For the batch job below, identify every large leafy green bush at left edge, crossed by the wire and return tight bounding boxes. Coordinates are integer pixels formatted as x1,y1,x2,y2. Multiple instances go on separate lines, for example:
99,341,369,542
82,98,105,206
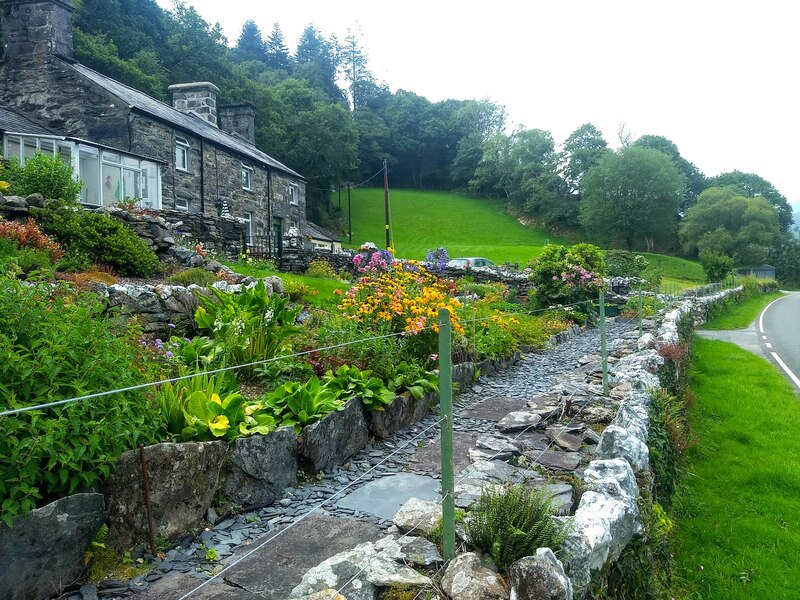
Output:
0,279,161,523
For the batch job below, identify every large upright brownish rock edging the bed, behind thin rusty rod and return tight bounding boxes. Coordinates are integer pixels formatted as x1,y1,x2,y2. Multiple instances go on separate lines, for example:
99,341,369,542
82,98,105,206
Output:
102,442,227,550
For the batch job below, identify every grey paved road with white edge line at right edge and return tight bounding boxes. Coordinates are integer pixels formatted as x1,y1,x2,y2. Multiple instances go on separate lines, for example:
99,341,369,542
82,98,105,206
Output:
757,293,800,389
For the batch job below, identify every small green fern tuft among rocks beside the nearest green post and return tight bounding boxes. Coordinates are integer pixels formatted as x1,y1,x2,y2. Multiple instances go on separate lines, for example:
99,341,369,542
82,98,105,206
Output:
465,483,570,571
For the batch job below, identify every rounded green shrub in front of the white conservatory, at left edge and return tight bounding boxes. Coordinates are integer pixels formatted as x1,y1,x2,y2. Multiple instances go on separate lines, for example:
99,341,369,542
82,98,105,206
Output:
3,152,83,204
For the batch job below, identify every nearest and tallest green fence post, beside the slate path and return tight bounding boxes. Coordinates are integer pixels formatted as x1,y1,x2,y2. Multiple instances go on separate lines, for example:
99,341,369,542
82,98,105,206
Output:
439,308,456,562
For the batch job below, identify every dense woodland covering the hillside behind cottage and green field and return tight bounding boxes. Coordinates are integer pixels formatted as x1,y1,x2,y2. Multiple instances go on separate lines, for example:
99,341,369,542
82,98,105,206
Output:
10,0,800,279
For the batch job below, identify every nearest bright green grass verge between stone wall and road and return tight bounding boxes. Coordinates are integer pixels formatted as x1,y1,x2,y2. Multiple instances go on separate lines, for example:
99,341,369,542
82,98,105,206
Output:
674,339,800,600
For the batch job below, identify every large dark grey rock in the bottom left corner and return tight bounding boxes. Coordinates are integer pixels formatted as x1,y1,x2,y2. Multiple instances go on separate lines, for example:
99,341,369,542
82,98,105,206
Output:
0,494,106,600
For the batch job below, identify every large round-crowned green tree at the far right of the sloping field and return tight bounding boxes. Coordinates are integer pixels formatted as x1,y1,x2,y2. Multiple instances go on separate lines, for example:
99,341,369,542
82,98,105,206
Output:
579,147,684,250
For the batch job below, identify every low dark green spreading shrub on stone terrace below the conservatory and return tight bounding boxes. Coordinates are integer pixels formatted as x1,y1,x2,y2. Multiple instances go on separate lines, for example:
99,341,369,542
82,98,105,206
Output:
31,208,161,277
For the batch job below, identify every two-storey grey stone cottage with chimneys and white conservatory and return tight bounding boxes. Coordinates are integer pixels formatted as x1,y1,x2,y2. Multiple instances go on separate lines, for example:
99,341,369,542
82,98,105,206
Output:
0,0,308,253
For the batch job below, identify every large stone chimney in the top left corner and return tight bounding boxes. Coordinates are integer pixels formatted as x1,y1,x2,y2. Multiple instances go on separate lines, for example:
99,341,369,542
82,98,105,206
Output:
0,0,75,63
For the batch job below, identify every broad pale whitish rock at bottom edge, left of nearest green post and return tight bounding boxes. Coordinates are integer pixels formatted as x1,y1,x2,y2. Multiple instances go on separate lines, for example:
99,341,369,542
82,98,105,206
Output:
289,542,430,600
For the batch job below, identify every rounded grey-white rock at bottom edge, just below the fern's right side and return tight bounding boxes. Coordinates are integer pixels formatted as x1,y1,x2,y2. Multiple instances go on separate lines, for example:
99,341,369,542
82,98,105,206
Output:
508,548,572,600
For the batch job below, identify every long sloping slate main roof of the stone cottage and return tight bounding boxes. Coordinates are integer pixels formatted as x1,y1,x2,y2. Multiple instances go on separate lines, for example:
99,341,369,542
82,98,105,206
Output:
64,61,305,181
